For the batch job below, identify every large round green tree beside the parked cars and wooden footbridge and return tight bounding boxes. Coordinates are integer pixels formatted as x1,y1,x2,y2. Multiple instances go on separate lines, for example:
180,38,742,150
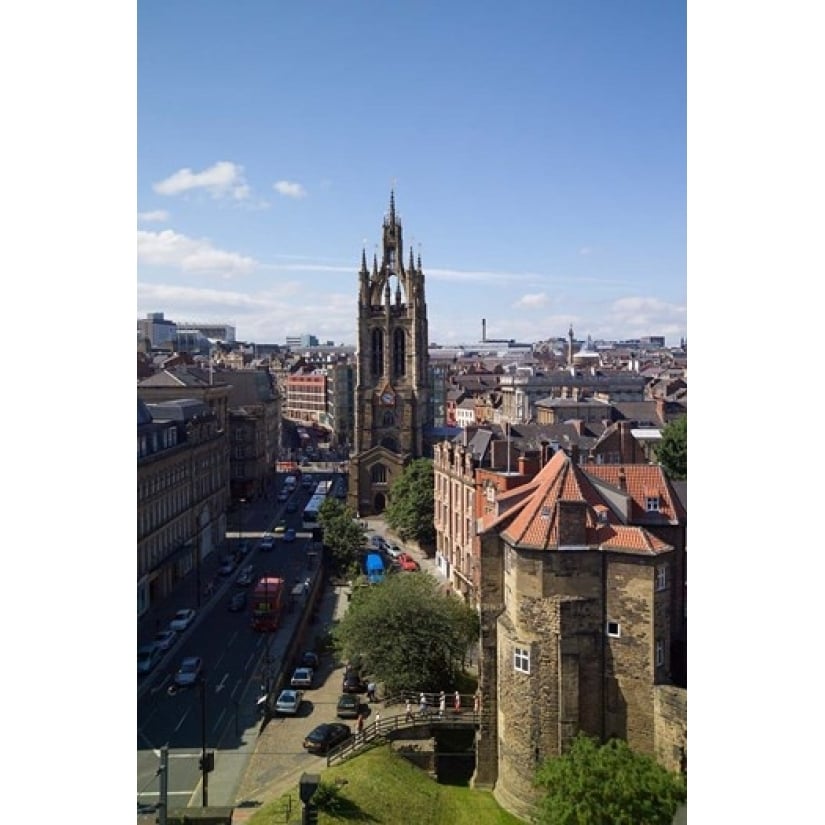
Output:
333,572,479,693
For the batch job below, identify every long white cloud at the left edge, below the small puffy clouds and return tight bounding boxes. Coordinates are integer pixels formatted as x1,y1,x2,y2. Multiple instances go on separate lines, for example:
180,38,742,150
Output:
137,229,258,278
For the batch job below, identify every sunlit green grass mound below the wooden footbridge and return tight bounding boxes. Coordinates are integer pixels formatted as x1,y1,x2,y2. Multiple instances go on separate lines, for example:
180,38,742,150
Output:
241,745,523,825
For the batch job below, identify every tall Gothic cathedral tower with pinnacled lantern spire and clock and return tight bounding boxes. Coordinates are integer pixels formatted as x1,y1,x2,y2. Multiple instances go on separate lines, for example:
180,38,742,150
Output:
348,192,429,517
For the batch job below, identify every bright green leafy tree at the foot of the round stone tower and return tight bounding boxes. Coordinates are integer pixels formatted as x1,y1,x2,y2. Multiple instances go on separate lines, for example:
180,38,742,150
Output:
534,734,687,825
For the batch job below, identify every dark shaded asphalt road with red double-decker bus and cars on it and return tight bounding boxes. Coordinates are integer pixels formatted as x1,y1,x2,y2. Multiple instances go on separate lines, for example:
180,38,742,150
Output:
137,474,330,823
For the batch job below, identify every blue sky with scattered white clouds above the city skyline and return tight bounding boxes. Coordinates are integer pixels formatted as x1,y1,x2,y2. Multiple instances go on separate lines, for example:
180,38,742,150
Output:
137,0,687,345
